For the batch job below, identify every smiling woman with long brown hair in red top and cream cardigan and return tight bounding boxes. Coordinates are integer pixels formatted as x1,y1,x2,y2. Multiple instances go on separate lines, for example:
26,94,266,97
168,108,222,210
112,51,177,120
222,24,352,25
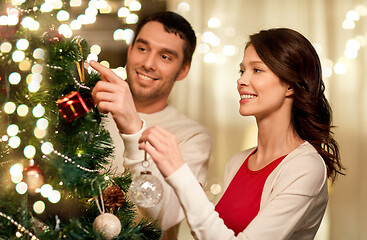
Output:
140,28,343,240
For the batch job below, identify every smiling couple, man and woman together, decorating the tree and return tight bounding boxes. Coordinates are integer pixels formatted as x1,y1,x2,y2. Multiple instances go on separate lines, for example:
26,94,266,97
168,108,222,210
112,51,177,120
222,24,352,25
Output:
90,12,343,240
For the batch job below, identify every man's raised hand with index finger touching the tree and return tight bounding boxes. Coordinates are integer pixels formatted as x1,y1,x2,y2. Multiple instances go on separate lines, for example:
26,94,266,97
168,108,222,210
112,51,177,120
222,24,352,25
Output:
89,61,142,134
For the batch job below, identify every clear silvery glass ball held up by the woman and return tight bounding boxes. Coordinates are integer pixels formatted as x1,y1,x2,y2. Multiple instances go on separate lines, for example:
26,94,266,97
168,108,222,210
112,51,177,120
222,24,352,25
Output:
129,171,163,208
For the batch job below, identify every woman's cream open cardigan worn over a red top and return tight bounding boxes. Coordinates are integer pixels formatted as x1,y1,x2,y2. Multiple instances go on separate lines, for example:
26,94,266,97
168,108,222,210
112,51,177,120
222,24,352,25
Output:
166,142,328,240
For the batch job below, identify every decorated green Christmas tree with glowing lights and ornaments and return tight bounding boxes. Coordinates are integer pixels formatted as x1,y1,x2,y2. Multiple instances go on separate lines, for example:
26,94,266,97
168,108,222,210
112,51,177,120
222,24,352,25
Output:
0,0,161,240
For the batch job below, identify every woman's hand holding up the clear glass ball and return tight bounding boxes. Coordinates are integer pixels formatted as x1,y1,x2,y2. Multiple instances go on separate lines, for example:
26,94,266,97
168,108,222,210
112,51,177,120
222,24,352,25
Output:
139,126,185,177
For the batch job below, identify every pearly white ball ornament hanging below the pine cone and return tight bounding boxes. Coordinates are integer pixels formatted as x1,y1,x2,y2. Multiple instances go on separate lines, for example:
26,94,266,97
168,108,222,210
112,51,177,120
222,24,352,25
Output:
93,213,121,240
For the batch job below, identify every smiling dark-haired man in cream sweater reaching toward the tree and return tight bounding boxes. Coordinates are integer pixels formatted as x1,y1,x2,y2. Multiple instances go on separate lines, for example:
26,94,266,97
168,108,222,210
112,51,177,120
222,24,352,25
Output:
90,12,211,240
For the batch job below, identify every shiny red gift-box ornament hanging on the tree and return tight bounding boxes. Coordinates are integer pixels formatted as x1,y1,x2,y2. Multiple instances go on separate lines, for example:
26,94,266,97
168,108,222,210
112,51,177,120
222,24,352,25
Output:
57,91,93,122
